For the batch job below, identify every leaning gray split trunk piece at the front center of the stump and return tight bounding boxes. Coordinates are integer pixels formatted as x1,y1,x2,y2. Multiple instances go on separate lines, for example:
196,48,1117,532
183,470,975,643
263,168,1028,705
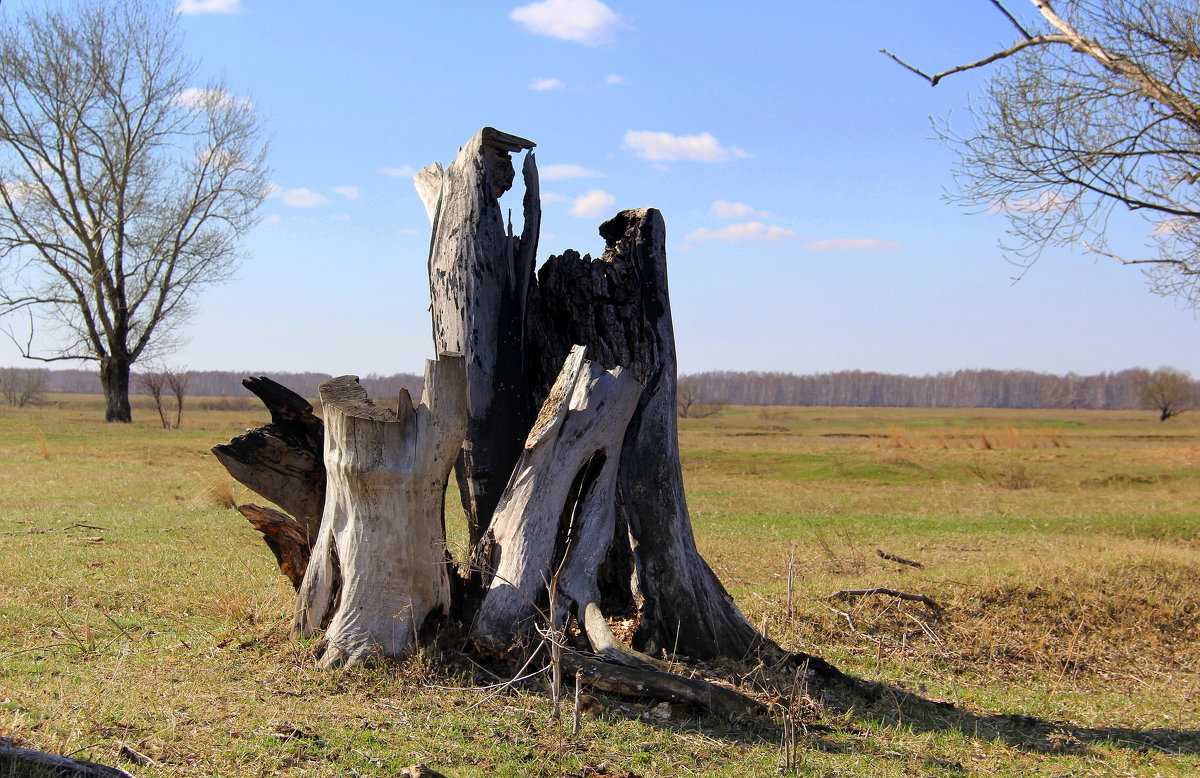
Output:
472,347,641,652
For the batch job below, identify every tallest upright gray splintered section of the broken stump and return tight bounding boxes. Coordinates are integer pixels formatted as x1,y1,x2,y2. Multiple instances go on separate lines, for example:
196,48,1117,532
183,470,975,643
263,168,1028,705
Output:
415,127,541,545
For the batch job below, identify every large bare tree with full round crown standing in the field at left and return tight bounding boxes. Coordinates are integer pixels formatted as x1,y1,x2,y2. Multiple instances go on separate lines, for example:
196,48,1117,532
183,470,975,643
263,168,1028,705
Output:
0,0,266,421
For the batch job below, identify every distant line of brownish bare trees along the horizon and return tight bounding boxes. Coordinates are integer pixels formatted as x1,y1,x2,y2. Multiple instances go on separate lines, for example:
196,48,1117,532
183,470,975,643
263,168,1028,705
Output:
14,367,1200,409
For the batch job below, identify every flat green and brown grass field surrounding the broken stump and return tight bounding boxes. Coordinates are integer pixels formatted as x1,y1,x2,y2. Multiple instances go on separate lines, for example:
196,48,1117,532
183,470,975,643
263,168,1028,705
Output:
0,397,1200,778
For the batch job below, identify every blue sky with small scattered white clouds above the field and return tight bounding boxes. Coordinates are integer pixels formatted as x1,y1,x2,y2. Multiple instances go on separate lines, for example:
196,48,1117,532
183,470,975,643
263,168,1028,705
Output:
0,0,1200,375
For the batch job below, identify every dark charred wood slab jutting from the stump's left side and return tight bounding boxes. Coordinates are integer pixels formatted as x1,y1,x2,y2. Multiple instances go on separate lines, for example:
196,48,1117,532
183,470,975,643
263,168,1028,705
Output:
212,376,325,538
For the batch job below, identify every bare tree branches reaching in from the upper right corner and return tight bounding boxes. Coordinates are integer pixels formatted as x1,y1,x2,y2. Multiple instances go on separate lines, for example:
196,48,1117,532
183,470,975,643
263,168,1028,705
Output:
884,0,1200,306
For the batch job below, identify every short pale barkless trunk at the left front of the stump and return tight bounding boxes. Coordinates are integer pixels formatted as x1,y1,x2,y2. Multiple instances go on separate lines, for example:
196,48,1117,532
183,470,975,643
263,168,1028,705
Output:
293,357,466,666
